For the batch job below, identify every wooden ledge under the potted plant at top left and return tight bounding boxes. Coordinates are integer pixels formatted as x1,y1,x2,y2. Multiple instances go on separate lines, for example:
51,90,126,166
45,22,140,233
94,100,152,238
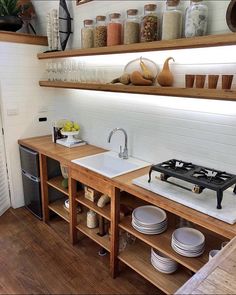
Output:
0,31,48,46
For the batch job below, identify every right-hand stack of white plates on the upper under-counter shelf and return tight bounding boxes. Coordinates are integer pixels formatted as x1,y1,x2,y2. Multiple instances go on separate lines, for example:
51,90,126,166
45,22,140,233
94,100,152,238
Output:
171,227,205,257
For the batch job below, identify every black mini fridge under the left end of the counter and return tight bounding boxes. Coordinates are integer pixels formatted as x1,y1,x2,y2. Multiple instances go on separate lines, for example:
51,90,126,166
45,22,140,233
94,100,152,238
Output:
19,145,42,219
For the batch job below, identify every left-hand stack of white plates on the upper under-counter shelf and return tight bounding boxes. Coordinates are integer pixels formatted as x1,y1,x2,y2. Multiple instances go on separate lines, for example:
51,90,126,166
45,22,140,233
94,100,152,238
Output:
132,205,167,235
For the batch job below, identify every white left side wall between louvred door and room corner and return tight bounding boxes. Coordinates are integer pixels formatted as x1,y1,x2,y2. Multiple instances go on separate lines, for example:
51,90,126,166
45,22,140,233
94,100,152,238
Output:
0,42,55,208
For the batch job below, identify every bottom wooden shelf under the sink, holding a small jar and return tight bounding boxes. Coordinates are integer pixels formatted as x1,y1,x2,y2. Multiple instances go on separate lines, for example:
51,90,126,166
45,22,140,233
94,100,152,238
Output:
76,213,110,252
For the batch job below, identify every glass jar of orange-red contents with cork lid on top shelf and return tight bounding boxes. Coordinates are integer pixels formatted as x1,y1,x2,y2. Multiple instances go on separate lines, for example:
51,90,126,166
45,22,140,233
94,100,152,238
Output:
107,13,122,46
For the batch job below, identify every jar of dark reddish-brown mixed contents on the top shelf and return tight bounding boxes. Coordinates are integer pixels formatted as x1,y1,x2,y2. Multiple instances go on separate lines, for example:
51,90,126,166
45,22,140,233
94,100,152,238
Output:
140,4,160,42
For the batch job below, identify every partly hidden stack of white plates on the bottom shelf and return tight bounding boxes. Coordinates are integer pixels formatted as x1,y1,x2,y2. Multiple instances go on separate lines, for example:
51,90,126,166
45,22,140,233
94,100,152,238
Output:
151,248,178,274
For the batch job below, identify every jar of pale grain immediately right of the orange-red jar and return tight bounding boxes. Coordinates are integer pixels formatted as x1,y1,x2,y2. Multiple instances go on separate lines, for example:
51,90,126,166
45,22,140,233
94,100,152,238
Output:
124,9,140,44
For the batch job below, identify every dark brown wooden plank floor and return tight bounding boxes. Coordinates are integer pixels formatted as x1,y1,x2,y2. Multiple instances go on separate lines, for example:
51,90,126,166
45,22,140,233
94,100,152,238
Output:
0,208,162,294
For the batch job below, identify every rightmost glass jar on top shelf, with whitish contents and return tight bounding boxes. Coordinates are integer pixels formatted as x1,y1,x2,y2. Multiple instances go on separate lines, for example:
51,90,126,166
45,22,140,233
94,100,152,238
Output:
185,0,208,38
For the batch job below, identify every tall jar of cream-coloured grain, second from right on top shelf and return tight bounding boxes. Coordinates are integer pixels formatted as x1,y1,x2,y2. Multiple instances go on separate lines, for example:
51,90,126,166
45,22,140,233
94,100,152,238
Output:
162,0,183,40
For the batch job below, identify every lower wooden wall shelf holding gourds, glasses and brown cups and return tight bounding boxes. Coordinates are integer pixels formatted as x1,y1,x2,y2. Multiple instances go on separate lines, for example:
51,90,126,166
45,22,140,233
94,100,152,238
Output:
39,81,236,101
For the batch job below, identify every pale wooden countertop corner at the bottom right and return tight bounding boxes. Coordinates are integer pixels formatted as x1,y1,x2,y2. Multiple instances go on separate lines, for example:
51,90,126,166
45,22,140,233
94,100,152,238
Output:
175,238,236,295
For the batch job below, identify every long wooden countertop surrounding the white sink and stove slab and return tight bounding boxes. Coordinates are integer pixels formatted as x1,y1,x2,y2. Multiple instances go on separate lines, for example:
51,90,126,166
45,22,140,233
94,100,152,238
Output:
18,135,236,239
